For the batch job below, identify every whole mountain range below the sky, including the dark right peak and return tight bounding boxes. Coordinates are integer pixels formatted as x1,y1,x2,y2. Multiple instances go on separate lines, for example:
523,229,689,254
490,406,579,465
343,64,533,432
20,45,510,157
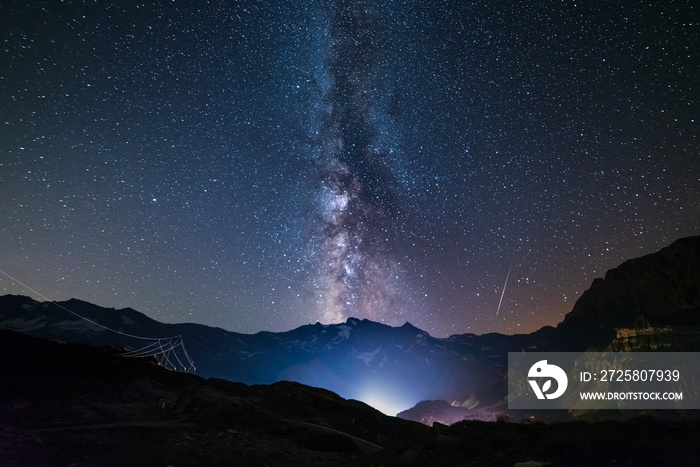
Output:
0,236,700,424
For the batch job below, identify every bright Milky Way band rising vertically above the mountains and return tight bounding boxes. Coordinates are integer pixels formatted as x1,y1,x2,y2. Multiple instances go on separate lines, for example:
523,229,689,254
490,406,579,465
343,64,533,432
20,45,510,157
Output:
310,2,410,322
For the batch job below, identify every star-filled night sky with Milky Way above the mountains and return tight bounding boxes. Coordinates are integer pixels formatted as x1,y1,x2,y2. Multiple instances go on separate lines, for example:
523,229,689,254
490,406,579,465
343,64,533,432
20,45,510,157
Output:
0,0,700,337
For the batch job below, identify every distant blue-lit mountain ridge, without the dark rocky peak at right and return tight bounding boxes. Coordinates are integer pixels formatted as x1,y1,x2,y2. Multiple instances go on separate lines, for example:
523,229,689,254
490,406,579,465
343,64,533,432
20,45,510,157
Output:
0,296,536,414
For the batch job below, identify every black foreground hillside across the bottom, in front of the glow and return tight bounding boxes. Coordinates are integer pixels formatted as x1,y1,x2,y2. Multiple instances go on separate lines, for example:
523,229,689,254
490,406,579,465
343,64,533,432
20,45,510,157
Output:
0,331,700,467
